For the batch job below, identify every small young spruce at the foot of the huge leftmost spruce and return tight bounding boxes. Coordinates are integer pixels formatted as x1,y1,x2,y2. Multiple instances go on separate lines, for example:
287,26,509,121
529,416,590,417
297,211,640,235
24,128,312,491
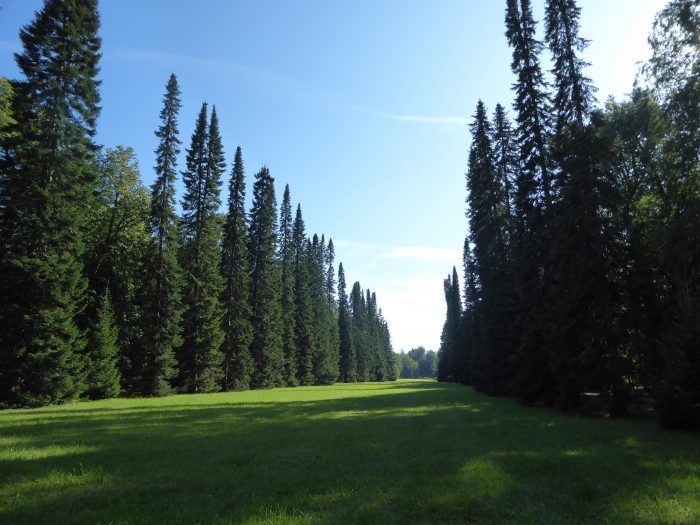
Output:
85,290,121,399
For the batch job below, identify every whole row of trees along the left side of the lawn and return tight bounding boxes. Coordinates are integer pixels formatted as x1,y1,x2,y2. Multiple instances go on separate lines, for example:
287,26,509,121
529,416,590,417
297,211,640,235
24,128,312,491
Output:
0,0,396,406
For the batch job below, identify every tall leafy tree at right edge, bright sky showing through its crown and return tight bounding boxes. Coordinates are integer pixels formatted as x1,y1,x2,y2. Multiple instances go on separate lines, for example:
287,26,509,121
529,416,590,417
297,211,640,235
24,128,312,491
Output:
646,0,700,430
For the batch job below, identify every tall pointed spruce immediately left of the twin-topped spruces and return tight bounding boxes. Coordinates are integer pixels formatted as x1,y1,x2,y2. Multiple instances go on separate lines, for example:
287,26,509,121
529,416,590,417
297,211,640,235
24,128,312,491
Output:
138,74,182,395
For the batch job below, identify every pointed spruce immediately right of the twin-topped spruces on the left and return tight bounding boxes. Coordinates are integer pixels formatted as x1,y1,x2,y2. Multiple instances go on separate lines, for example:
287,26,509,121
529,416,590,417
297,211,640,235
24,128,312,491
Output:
221,146,253,390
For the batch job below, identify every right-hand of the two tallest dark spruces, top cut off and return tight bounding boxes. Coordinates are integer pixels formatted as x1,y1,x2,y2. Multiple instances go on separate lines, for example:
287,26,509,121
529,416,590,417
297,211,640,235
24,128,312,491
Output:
546,0,625,410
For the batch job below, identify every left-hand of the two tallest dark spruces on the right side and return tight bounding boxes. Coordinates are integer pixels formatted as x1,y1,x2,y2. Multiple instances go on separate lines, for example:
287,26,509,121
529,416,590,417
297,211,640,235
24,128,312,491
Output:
506,0,554,402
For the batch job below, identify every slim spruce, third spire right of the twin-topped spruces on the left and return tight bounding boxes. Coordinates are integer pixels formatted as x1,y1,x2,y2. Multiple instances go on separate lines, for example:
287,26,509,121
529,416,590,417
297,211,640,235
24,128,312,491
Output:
279,184,298,386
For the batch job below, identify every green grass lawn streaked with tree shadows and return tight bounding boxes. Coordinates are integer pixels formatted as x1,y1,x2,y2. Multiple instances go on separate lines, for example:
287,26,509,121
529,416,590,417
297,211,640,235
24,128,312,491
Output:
0,381,700,525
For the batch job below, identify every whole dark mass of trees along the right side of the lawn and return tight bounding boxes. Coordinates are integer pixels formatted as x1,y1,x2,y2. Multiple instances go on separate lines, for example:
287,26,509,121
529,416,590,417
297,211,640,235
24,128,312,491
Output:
438,0,700,430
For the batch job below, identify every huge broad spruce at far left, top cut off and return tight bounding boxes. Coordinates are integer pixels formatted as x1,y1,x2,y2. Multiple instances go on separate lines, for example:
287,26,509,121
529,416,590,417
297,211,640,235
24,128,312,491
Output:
0,0,100,405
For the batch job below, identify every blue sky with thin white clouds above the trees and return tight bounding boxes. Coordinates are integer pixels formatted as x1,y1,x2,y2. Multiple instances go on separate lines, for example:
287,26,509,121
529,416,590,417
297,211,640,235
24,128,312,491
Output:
0,0,665,351
